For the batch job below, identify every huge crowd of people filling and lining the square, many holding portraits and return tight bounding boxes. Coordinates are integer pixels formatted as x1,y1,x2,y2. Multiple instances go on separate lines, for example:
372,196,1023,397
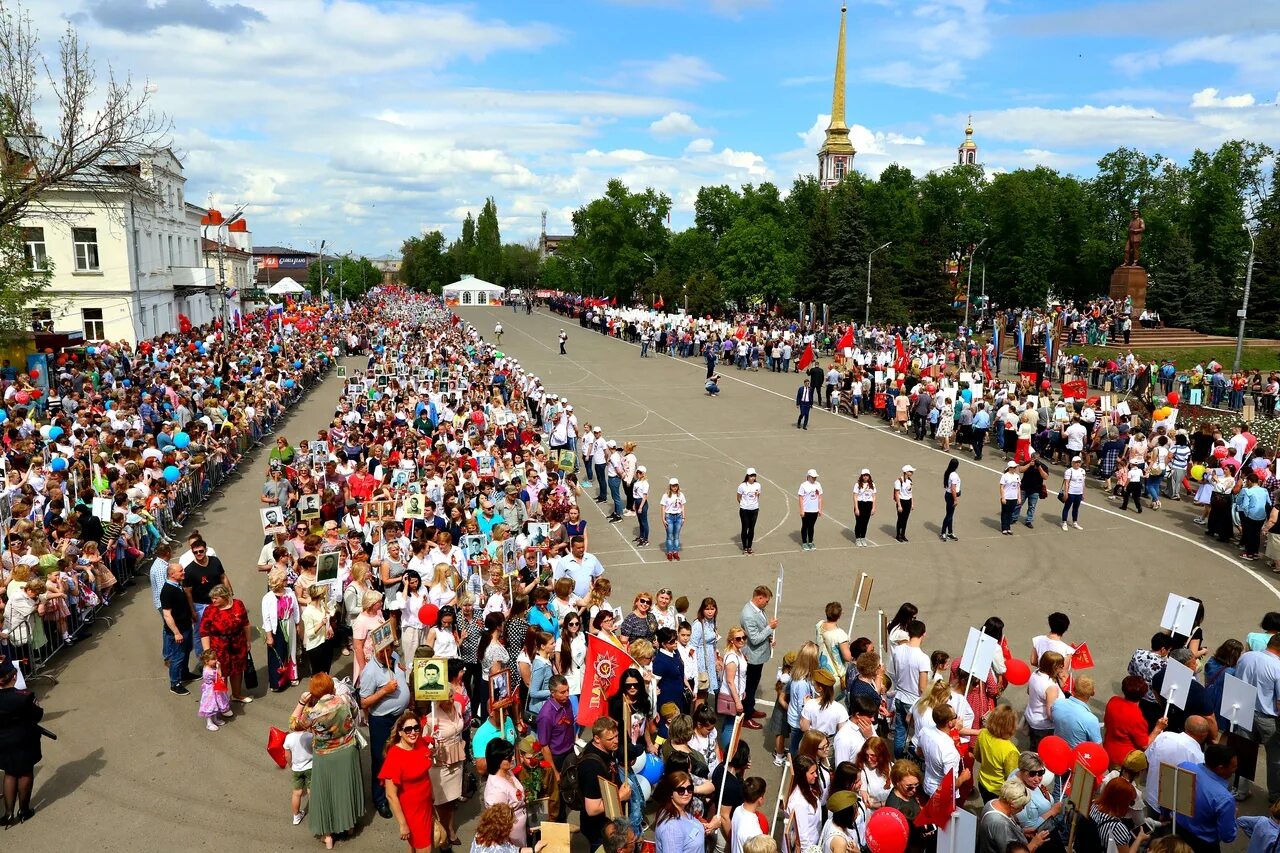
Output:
0,288,1280,853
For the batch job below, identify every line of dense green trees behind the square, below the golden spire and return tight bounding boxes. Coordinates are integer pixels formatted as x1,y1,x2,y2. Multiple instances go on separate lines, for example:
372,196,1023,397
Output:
394,141,1280,337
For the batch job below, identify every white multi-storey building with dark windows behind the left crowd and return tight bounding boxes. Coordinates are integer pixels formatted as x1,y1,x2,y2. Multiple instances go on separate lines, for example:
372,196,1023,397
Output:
22,150,220,343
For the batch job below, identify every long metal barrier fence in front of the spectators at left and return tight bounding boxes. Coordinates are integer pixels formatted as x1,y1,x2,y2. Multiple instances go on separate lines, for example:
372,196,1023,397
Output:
0,362,333,683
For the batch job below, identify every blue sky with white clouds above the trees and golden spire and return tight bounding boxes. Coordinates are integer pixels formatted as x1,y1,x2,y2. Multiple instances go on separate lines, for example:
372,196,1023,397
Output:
27,0,1280,255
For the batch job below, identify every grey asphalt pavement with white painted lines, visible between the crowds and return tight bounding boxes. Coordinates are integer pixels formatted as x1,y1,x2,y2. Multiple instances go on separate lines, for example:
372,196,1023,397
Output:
17,309,1280,853
